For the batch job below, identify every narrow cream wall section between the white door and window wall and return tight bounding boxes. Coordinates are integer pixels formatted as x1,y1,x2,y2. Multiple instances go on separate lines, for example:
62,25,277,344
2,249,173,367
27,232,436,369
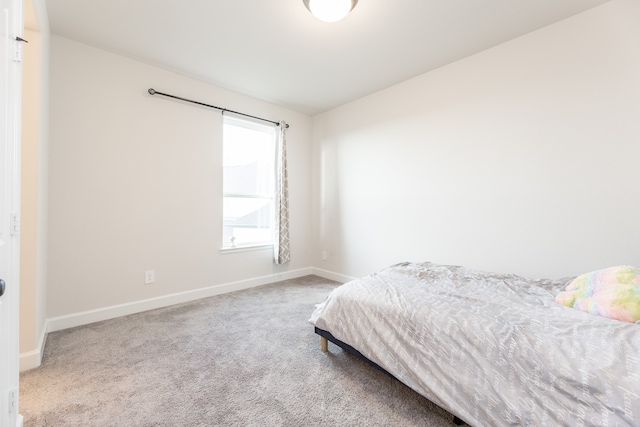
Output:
20,0,49,370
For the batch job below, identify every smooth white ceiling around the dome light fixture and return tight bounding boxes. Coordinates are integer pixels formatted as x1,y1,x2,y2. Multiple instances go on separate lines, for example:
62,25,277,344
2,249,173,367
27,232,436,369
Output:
41,0,608,115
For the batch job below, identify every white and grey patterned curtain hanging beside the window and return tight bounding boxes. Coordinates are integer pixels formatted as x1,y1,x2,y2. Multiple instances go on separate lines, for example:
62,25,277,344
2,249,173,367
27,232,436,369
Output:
273,121,291,264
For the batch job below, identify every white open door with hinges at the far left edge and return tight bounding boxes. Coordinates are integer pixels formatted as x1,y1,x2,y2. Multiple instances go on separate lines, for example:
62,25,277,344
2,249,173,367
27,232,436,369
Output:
0,0,23,427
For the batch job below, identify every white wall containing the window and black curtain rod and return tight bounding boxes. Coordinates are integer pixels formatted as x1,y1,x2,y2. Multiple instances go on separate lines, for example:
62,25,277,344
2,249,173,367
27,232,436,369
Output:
48,36,311,318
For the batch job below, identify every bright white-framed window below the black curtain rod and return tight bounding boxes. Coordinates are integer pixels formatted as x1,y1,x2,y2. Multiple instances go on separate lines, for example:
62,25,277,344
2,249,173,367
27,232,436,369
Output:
222,115,276,249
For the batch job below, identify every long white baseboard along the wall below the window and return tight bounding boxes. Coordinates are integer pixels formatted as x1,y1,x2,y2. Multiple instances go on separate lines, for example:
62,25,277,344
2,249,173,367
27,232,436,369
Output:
48,268,314,332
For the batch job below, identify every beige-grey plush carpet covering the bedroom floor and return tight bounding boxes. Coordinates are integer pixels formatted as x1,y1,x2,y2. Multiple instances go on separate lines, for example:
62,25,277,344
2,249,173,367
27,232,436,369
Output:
20,276,460,427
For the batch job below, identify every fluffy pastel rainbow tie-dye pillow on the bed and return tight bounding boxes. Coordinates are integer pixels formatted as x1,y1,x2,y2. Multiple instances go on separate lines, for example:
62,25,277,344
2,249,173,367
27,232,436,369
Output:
556,266,640,323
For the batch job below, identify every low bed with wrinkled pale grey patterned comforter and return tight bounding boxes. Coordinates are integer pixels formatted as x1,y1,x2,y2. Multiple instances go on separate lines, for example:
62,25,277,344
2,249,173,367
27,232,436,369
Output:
309,262,640,426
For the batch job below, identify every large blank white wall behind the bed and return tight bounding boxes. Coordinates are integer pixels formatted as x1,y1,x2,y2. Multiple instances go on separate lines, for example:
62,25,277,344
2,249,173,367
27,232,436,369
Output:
313,0,640,278
